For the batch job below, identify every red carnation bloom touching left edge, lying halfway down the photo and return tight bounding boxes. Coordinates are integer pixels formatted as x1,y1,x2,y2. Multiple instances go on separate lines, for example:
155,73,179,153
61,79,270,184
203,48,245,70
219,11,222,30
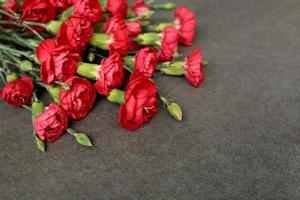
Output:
0,76,33,106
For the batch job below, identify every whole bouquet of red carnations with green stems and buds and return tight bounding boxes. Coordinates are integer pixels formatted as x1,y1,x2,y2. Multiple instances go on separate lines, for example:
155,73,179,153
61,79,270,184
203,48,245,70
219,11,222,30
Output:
0,0,207,151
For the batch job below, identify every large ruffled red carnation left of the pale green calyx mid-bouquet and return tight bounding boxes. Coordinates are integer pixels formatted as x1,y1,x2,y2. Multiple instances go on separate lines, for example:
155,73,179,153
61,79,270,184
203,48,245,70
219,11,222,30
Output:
37,39,81,84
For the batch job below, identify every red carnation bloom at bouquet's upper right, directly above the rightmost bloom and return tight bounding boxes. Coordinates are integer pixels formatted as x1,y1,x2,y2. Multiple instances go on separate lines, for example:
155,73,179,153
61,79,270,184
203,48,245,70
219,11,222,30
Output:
174,6,196,46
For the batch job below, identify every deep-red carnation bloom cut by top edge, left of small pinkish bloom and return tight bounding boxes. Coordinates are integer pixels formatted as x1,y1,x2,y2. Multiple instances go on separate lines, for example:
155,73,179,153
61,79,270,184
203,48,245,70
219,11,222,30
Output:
106,0,128,18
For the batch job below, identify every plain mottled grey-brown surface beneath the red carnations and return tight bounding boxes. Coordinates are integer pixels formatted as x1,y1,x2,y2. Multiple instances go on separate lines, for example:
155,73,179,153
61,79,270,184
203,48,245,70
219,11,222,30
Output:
0,0,300,200
